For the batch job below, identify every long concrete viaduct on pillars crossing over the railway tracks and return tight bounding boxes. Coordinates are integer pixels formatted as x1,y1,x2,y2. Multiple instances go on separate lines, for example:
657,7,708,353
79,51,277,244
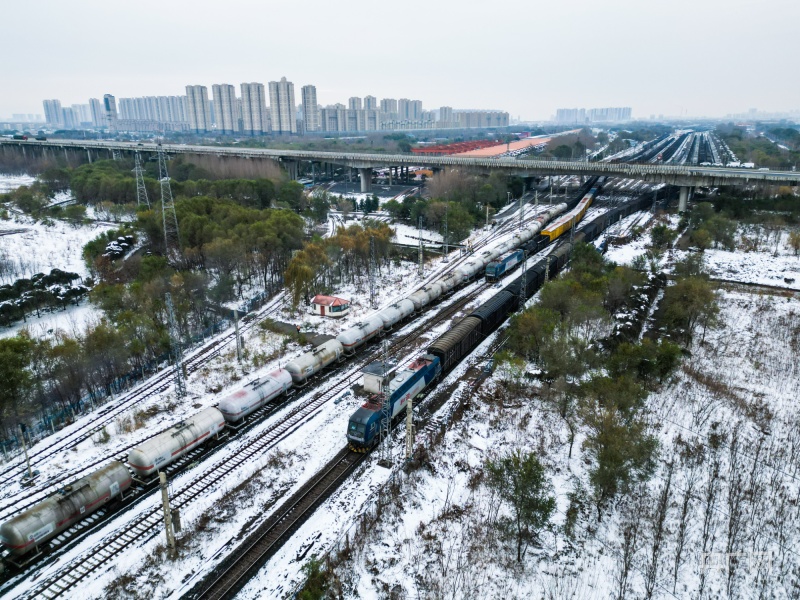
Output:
0,139,800,210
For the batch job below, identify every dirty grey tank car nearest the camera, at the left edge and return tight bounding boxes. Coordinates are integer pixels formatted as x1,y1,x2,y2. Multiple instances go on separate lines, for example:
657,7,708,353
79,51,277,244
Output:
0,460,131,556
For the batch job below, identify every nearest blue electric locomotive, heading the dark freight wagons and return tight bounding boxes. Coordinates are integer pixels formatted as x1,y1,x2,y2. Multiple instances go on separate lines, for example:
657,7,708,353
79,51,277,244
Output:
347,354,442,452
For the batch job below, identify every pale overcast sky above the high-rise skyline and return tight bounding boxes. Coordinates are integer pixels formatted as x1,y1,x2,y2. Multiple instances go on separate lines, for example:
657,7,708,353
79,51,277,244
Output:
0,0,800,119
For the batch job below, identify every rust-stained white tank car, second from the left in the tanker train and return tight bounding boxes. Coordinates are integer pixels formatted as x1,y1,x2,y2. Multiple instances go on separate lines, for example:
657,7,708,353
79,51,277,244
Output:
128,408,225,477
